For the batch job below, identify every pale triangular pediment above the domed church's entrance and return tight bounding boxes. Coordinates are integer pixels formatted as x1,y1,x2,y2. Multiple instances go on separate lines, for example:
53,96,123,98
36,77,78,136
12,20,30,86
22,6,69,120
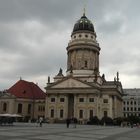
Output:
51,78,91,88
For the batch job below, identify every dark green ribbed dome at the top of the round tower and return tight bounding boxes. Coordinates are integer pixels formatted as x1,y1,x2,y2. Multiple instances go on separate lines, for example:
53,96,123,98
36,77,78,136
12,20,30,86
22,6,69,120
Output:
73,14,94,33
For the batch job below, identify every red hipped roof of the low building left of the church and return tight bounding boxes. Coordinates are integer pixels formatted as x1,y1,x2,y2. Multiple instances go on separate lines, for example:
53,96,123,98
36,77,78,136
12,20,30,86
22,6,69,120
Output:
7,80,46,99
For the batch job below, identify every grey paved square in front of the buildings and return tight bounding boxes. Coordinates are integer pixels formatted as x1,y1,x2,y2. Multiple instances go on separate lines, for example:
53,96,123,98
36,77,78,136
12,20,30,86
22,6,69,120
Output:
0,123,140,140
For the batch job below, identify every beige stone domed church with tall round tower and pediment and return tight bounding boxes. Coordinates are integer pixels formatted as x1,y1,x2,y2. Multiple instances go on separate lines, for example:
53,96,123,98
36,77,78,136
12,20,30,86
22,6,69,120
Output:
45,13,123,123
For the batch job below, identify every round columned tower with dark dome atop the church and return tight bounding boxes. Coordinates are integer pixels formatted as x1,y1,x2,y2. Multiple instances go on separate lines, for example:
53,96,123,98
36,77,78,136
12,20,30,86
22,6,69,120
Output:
67,12,100,82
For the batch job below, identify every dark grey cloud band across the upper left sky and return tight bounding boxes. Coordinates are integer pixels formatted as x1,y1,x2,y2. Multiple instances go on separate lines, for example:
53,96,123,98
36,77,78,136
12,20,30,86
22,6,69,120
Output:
0,0,82,22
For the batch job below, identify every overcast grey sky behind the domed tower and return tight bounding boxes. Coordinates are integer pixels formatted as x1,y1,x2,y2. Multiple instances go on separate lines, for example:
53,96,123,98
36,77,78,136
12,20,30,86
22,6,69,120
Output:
0,0,140,90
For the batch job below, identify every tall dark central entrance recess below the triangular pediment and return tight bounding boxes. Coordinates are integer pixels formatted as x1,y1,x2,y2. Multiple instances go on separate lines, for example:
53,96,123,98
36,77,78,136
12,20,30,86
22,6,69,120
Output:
68,94,74,118
